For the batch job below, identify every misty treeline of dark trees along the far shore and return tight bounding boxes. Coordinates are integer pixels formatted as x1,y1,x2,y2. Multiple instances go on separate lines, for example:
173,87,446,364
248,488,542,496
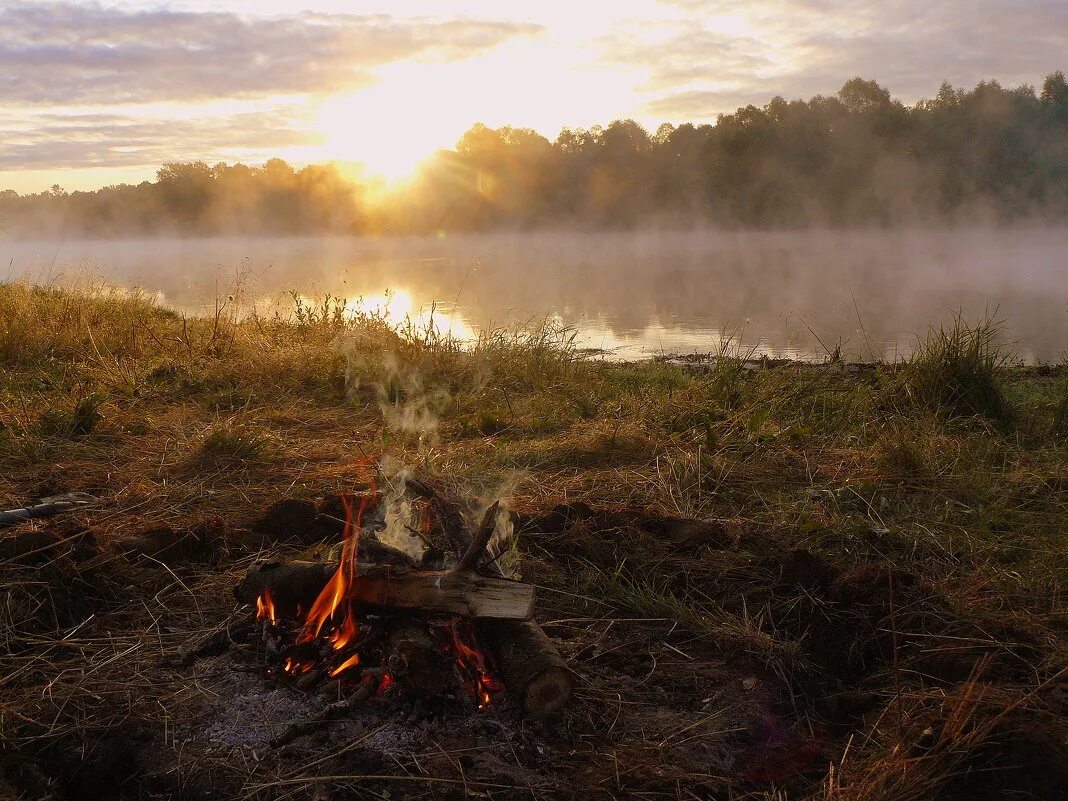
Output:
0,72,1068,237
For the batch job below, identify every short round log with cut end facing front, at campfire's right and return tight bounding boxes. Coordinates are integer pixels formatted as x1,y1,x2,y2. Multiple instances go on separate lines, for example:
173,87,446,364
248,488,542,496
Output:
477,621,575,717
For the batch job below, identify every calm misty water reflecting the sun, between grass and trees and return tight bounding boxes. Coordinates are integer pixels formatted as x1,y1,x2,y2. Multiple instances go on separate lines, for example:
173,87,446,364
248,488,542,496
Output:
0,227,1068,361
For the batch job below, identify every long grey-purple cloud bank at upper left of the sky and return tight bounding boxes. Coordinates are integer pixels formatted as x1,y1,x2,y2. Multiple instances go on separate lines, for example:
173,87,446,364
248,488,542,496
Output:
0,2,541,106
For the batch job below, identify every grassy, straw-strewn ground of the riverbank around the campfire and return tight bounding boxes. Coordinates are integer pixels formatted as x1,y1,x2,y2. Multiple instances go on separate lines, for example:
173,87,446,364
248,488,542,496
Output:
0,285,1068,800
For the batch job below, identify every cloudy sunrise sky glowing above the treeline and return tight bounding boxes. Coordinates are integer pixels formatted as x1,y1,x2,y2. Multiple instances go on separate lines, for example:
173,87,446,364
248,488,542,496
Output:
0,0,1068,192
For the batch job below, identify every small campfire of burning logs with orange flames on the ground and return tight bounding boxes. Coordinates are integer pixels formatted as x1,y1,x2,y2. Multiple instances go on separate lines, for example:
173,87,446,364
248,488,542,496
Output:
235,490,574,735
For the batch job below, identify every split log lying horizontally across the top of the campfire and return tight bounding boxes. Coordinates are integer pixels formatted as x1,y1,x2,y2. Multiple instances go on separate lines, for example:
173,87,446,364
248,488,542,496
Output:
234,562,534,621
